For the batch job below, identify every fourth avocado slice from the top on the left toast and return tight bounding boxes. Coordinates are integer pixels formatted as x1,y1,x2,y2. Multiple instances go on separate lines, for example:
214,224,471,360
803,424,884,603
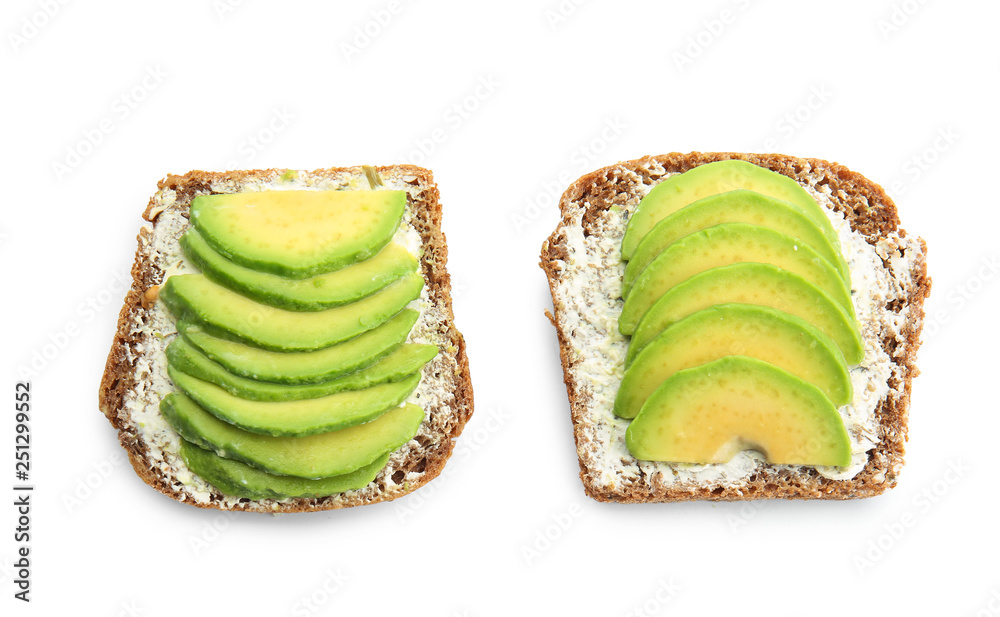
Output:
177,309,420,384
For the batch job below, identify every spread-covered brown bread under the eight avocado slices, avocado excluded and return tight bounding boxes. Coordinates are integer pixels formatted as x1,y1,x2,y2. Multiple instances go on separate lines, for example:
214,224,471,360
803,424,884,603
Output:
99,165,473,513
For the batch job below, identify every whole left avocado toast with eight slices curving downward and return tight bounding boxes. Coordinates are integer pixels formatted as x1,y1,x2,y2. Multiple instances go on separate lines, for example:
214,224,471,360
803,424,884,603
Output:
99,165,473,513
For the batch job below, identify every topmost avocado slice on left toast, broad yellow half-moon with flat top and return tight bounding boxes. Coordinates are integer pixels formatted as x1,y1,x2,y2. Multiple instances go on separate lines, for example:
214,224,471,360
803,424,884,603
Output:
190,191,406,279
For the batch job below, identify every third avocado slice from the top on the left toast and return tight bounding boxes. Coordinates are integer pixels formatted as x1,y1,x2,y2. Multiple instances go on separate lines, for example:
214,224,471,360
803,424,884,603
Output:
159,273,424,351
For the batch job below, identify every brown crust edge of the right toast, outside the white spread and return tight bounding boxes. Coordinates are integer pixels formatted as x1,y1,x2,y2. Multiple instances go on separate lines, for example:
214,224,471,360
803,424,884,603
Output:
540,152,931,503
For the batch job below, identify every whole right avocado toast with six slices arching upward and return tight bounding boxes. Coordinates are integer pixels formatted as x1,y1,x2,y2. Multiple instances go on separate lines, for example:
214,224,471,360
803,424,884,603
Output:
540,152,931,503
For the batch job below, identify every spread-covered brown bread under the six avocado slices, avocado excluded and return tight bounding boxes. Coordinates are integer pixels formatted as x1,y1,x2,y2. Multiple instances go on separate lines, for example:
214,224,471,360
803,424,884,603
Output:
540,152,931,503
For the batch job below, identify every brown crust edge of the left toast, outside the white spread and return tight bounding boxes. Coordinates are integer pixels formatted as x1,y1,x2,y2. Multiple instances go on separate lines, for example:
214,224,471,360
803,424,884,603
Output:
98,165,473,513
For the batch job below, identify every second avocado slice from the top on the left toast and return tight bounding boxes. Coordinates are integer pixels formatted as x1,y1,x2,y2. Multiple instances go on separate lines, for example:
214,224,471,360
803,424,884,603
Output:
181,228,417,311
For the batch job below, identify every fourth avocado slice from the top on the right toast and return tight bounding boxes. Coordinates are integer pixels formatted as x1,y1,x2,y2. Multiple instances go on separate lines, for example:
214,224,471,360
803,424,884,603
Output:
625,263,865,366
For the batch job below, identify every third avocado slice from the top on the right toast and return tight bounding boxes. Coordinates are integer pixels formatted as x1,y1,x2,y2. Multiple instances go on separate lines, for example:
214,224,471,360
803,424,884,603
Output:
618,223,854,335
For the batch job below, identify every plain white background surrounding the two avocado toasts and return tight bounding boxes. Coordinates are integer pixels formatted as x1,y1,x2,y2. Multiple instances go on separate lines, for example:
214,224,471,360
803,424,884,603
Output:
0,0,1000,616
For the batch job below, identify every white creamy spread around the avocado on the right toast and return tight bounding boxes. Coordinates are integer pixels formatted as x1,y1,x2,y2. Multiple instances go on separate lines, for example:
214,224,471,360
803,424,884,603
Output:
553,163,921,488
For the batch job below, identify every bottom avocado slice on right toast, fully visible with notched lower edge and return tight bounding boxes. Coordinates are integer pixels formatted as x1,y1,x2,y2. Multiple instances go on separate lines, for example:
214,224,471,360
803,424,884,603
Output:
625,356,851,467
